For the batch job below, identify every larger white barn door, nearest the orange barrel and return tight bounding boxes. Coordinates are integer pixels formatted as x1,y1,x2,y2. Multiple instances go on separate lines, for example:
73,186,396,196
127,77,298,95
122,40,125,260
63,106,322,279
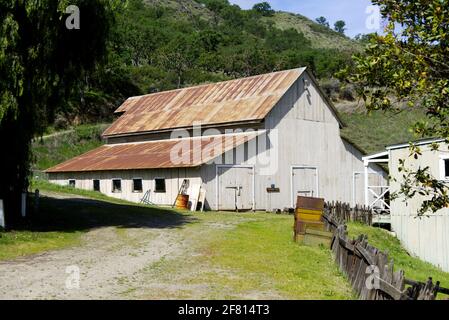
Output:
217,166,254,211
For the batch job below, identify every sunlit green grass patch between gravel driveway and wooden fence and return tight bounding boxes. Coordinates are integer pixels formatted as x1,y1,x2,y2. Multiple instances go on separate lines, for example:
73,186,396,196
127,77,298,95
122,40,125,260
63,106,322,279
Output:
201,214,354,299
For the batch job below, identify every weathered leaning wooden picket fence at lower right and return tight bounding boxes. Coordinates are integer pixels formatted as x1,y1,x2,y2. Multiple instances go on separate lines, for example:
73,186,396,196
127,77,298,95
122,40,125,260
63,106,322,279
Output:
323,204,449,300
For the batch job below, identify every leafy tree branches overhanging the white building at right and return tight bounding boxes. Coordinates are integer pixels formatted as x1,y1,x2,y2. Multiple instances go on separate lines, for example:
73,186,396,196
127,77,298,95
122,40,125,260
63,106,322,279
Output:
341,0,449,215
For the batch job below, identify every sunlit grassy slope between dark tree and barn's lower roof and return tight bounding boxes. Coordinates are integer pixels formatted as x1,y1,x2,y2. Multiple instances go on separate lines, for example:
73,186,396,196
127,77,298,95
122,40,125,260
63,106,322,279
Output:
33,124,107,170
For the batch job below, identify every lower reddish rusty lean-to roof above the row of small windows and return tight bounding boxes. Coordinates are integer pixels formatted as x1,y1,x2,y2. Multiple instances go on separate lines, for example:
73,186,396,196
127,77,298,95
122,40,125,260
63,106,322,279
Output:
46,131,263,173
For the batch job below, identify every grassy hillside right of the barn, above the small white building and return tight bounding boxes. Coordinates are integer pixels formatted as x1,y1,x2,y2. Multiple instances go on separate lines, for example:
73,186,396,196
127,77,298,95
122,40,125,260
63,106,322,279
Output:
340,110,425,153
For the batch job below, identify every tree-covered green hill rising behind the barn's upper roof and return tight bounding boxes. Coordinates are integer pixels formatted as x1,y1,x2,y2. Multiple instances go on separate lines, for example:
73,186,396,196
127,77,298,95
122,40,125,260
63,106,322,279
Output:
56,0,360,128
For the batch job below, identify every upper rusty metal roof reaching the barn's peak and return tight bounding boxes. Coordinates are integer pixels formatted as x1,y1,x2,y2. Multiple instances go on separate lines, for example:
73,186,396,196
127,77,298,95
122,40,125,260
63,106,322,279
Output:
103,68,305,136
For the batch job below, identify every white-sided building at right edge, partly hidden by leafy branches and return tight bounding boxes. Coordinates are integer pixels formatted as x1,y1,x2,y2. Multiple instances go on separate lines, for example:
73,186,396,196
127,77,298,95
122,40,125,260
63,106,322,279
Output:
387,140,449,271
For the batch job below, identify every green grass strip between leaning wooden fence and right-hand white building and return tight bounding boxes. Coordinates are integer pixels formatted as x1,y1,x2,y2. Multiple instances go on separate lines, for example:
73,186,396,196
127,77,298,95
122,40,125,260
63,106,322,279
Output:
348,223,449,288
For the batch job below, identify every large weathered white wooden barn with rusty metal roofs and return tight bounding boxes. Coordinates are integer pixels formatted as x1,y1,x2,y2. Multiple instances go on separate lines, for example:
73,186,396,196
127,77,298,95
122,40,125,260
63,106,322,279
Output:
46,68,387,211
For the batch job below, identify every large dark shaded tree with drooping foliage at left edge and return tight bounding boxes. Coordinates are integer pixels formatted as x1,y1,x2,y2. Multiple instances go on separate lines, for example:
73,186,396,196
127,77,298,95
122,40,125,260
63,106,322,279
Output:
0,0,118,224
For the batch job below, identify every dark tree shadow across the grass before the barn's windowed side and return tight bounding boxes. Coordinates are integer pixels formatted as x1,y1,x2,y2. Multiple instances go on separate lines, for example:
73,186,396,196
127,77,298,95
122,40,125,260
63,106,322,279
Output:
14,196,196,232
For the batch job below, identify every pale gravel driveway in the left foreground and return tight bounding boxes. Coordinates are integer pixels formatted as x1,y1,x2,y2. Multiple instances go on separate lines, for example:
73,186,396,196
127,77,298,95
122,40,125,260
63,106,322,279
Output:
0,195,189,299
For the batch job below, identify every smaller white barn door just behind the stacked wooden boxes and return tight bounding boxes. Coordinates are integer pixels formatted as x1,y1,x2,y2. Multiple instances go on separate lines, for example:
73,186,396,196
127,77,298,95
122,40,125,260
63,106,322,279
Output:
292,167,318,205
